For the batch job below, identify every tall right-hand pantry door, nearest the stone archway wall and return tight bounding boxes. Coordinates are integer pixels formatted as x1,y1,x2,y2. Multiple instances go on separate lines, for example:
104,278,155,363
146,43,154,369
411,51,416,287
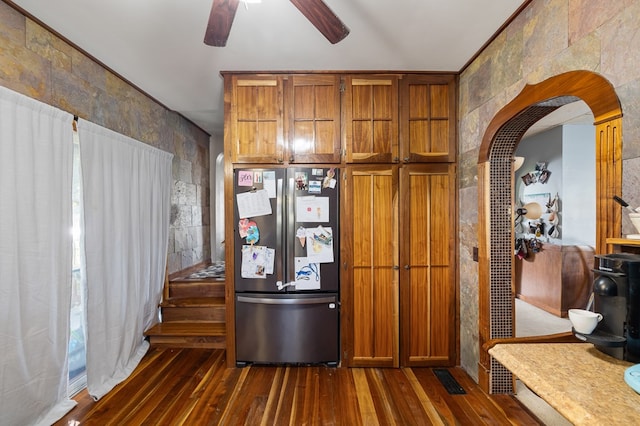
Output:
400,164,458,366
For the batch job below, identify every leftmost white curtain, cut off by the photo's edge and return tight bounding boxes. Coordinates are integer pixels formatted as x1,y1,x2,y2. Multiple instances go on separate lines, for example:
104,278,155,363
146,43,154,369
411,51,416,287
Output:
0,87,75,426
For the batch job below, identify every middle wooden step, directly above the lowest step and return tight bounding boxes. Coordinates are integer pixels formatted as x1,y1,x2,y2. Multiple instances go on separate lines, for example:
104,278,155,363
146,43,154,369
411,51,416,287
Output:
160,297,226,322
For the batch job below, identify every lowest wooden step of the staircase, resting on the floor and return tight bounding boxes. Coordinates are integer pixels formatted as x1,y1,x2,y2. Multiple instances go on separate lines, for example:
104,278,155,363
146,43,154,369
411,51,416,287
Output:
144,322,226,349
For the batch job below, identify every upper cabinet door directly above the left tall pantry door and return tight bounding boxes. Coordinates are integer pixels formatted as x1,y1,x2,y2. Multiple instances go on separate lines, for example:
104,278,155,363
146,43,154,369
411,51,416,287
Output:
342,75,399,163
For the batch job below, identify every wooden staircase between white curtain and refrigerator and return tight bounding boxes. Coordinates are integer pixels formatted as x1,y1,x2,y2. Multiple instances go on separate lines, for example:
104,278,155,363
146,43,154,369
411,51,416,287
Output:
145,265,226,349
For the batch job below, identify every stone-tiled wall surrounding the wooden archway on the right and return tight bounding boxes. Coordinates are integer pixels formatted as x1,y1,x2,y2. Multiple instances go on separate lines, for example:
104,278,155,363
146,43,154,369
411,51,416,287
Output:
458,0,640,378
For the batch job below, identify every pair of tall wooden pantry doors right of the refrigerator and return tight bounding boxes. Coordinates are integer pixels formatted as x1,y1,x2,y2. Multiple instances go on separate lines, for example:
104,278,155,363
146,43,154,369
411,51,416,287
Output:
343,164,458,367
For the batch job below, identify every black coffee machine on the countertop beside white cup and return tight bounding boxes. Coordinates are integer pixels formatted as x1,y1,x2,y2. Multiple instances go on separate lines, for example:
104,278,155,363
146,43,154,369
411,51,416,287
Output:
576,253,640,363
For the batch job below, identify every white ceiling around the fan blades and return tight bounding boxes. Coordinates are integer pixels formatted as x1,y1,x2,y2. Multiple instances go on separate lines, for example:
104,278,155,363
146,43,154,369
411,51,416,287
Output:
13,0,525,134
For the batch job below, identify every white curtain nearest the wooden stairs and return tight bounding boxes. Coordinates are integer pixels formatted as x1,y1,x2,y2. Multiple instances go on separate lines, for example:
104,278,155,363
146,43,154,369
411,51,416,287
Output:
78,120,173,400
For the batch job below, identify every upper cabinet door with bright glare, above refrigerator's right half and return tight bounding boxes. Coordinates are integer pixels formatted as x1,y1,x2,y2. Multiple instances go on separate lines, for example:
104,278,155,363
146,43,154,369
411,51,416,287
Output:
285,74,341,163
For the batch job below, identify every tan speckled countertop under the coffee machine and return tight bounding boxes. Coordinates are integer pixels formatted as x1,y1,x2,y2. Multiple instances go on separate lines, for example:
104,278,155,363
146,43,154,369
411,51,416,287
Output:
489,343,640,425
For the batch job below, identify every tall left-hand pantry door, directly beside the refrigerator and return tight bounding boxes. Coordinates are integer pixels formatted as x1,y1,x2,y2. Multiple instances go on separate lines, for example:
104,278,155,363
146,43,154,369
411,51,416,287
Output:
343,166,399,366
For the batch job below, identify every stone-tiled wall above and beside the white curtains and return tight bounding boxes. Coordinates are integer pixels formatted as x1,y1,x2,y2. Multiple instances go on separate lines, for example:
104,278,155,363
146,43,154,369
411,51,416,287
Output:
0,2,211,272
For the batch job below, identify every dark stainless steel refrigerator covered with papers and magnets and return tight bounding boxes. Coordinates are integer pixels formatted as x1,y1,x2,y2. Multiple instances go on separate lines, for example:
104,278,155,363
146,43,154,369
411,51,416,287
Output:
234,167,340,366
